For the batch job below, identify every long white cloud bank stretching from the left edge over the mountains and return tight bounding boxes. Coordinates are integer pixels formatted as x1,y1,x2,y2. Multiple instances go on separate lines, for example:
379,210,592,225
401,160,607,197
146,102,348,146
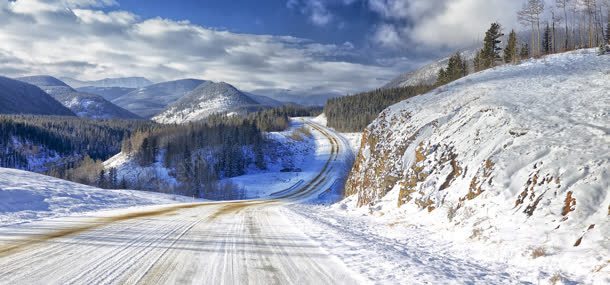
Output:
0,0,399,93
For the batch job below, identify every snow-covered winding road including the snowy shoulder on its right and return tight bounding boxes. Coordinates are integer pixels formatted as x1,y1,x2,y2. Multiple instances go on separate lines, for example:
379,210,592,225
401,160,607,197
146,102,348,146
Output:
0,119,560,285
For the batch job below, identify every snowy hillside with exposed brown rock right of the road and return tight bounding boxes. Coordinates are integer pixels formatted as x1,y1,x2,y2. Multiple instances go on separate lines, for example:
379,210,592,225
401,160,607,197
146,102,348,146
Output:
344,50,610,284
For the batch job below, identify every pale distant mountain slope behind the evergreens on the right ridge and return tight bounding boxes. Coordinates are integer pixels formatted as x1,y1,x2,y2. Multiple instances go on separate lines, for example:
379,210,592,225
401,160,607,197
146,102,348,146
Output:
382,49,477,89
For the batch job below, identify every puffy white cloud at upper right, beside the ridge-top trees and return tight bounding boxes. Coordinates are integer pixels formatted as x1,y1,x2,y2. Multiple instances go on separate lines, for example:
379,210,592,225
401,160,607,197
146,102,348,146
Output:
368,0,522,48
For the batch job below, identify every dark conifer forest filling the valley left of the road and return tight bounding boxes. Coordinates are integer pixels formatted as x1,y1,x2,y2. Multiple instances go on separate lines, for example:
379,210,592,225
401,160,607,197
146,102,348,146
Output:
0,106,322,199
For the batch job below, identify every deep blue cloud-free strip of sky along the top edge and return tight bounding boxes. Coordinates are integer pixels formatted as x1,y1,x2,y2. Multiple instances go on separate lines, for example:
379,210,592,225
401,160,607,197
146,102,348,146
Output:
110,0,379,45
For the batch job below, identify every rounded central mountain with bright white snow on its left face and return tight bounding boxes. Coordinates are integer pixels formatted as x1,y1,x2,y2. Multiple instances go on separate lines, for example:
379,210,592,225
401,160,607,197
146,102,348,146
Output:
153,82,267,124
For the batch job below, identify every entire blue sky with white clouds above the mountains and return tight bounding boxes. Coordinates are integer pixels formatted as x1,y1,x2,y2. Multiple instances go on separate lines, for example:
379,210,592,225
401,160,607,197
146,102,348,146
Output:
0,0,521,96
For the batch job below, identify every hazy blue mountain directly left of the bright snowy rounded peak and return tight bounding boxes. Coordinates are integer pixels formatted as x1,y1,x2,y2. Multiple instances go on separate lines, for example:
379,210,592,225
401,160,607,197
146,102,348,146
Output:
112,79,206,118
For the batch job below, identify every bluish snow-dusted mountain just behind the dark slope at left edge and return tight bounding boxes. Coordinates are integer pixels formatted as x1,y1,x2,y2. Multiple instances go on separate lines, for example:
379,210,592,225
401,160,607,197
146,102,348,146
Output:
17,75,139,119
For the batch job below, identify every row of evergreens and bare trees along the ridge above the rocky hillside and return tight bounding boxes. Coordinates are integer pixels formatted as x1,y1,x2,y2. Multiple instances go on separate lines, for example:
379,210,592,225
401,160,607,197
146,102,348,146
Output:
324,0,610,132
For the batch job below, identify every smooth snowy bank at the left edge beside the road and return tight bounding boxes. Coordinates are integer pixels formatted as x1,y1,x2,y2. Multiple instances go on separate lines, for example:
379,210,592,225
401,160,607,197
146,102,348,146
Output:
0,168,192,226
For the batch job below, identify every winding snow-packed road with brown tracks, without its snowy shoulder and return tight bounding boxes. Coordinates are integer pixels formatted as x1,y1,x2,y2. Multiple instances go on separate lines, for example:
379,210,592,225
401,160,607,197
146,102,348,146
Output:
0,117,362,284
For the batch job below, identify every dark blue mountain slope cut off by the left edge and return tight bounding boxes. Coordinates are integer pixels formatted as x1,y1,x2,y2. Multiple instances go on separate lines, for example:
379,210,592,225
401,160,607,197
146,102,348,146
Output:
0,76,74,116
